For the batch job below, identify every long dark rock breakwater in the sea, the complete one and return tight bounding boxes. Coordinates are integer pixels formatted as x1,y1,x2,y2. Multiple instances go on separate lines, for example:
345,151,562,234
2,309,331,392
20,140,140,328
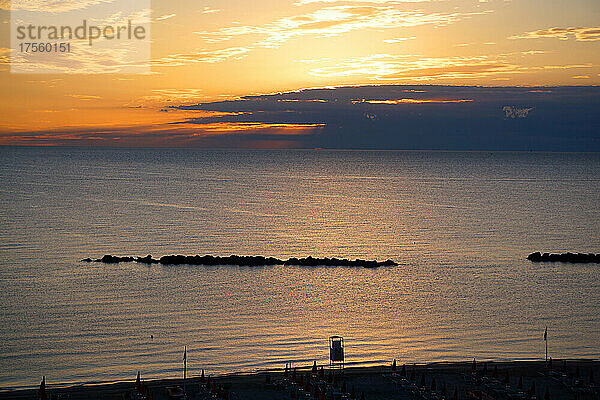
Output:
81,254,398,268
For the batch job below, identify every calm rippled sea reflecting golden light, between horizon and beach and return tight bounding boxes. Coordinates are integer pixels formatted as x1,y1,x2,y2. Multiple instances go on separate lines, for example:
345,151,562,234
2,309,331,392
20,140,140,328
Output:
0,147,600,387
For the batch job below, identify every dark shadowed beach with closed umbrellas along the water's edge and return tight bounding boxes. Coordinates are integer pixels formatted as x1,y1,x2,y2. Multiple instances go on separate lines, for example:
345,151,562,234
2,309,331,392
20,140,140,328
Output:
0,360,600,400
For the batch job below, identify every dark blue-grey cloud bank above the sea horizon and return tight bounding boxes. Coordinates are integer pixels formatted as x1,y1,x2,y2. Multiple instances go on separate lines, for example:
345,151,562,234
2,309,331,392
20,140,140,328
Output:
175,85,600,151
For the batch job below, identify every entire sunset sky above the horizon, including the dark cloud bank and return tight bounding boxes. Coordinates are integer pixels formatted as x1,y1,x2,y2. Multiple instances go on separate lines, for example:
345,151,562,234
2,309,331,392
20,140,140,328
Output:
0,0,600,150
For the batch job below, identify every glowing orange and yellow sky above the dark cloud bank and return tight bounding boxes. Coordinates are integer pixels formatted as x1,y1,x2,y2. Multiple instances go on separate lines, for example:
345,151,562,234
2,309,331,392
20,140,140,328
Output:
0,0,600,145
